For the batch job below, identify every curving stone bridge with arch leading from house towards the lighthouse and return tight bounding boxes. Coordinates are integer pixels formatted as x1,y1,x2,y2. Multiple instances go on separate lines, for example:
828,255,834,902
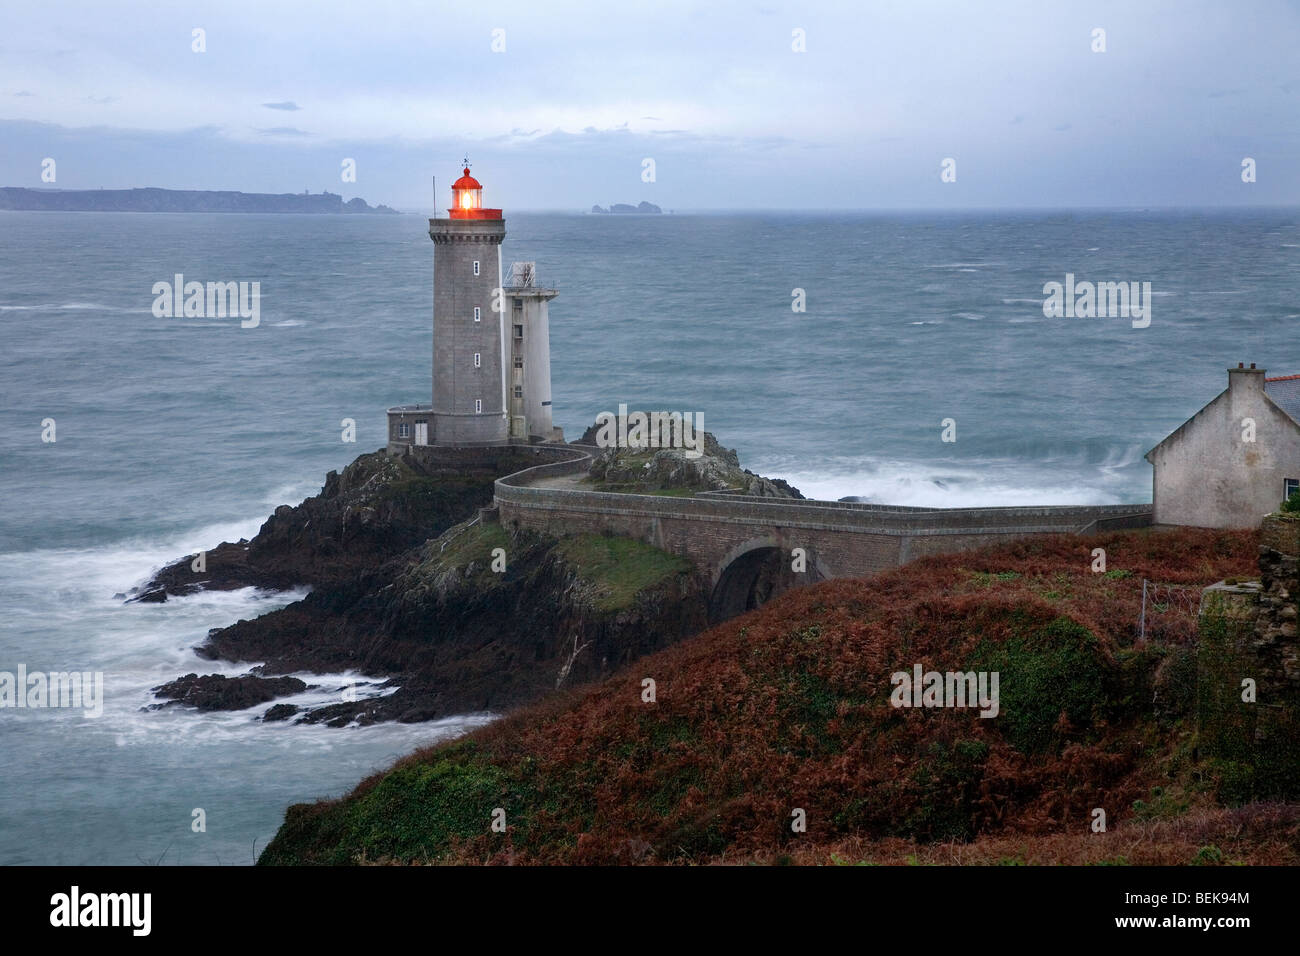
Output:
495,445,1152,622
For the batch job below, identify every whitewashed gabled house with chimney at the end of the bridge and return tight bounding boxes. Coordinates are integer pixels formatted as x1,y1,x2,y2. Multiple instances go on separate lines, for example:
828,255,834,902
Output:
1145,363,1300,528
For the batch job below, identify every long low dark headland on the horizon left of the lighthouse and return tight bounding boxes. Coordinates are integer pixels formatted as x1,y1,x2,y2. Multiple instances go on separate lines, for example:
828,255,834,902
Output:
0,186,399,216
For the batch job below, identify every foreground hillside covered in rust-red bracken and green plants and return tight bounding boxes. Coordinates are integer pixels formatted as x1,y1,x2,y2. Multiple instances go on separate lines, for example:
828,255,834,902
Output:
261,522,1300,864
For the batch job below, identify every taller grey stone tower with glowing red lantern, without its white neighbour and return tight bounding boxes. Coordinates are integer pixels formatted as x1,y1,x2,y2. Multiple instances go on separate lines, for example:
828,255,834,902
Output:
429,165,510,445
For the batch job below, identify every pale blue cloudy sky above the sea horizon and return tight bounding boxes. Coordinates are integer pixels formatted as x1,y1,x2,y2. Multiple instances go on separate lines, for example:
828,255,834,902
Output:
0,0,1300,212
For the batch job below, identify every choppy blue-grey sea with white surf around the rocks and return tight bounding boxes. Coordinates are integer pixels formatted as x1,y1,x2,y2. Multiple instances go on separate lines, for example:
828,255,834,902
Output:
0,209,1300,865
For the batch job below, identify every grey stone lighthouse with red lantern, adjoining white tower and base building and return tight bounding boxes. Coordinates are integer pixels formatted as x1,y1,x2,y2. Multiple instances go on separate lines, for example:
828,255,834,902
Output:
389,160,563,454
